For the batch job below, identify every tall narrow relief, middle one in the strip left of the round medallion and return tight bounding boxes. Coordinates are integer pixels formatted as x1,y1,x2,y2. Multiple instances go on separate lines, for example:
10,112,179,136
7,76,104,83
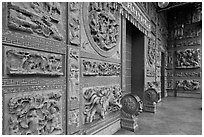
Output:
68,48,80,109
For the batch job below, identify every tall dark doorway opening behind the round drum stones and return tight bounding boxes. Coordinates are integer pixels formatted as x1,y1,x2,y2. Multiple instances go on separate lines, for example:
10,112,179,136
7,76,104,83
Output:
126,21,145,100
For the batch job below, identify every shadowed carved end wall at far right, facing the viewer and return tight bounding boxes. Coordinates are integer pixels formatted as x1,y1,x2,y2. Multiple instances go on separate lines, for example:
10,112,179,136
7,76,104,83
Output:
168,2,202,98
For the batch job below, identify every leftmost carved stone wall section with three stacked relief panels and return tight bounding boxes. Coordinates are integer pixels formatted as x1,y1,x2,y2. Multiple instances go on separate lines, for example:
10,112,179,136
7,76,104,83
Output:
2,2,67,135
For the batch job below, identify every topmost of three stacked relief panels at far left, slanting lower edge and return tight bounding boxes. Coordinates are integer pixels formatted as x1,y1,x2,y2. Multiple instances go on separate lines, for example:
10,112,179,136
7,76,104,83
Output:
8,2,64,41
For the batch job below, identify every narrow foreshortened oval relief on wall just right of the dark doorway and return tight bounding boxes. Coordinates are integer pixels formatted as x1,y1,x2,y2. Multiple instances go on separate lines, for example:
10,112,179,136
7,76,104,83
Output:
147,38,156,66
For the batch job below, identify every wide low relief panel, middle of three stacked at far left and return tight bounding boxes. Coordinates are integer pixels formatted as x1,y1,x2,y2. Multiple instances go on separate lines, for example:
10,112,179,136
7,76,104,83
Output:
5,47,64,76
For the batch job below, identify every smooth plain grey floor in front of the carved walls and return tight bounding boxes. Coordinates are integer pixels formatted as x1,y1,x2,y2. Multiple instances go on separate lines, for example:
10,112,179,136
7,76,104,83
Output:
115,97,202,135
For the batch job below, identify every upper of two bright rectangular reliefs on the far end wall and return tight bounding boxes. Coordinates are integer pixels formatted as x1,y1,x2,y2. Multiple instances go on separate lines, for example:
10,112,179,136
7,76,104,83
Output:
175,49,201,68
